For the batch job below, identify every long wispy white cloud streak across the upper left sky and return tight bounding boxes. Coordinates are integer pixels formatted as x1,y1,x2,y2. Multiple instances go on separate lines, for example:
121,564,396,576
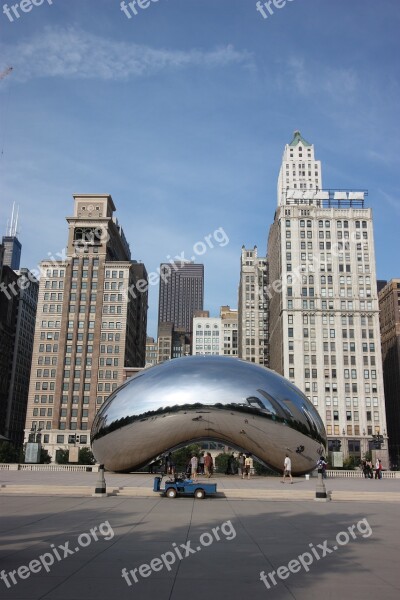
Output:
0,27,252,81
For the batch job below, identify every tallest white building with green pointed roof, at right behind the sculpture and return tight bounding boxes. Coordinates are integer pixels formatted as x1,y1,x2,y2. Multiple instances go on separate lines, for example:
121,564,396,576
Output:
268,131,387,461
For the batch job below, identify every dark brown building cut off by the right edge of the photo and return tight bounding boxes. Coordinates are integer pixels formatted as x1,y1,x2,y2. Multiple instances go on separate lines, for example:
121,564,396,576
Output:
379,279,400,468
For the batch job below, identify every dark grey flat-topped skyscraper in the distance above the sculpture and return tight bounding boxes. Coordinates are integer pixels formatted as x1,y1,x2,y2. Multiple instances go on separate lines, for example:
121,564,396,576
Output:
158,261,204,333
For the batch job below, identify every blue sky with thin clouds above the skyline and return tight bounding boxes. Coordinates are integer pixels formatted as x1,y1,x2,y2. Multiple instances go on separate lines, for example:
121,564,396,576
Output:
0,0,400,335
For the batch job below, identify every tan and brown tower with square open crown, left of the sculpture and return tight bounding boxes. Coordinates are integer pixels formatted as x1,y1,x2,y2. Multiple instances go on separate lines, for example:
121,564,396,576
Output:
25,194,147,458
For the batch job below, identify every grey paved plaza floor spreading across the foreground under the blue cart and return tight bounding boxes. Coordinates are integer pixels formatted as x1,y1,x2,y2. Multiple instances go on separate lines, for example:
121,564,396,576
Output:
0,472,400,600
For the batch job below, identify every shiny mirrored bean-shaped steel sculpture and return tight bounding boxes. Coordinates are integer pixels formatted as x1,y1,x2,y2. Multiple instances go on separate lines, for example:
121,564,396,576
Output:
91,356,326,475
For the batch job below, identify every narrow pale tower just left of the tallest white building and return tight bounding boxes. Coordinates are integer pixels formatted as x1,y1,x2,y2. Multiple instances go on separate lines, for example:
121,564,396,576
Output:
238,246,269,366
